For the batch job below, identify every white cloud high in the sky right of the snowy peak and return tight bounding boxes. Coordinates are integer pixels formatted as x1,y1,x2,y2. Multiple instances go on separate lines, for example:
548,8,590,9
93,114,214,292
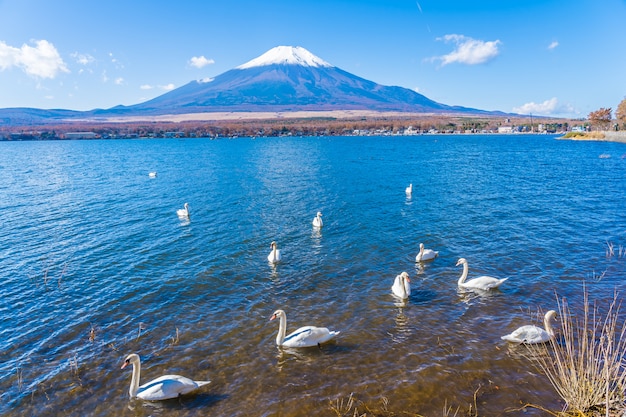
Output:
431,34,501,66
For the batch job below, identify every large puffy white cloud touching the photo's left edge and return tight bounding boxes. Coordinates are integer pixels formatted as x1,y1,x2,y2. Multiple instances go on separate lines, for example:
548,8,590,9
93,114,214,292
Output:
0,40,70,78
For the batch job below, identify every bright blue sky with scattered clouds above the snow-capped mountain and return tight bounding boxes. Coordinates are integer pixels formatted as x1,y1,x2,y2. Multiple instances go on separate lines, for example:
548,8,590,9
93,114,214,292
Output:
0,0,626,117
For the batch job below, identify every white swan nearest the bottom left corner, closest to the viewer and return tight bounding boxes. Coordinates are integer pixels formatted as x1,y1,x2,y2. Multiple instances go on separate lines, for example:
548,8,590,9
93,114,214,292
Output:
122,353,211,401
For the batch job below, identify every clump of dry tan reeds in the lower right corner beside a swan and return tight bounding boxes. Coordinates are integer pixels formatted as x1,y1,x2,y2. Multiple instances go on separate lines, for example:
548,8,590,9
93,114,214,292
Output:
527,290,626,417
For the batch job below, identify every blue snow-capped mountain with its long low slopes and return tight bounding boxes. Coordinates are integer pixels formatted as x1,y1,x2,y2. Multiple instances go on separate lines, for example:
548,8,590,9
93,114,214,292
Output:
0,46,503,123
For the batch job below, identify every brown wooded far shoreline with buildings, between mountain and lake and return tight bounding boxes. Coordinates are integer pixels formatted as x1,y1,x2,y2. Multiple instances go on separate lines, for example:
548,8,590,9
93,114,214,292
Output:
0,115,573,140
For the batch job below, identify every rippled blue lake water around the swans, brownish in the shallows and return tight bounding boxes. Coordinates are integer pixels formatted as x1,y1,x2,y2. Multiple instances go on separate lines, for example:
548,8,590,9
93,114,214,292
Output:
0,135,626,416
